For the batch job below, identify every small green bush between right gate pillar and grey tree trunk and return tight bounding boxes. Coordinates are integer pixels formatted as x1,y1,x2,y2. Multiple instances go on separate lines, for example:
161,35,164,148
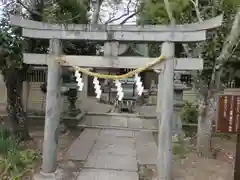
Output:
181,102,198,124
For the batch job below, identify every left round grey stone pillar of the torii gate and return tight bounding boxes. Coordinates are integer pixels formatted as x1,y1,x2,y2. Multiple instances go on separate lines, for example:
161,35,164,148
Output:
42,39,62,173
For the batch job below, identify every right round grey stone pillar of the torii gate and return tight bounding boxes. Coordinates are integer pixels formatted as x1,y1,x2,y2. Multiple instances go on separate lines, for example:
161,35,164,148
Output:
157,42,175,180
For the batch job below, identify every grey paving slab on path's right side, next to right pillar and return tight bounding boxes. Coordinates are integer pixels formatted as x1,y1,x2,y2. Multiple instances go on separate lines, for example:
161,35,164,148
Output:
135,132,157,165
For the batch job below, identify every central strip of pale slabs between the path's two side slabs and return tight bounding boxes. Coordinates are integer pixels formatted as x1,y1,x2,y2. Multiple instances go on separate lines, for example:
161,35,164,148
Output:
84,130,137,171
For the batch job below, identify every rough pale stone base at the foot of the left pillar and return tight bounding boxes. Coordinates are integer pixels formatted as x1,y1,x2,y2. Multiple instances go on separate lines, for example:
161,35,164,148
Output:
33,169,79,180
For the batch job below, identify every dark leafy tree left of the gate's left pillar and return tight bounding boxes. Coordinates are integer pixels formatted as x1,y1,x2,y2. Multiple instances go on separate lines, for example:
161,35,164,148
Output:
0,4,30,139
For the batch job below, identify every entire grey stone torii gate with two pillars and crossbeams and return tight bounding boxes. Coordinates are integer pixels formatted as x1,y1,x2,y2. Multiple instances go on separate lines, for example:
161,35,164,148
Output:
10,16,222,180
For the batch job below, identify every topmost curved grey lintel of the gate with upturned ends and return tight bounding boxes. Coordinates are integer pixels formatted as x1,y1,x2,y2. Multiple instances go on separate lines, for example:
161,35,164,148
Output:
10,15,223,32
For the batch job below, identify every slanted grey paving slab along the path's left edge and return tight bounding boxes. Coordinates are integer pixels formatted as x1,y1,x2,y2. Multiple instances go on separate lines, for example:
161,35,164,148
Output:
67,129,101,161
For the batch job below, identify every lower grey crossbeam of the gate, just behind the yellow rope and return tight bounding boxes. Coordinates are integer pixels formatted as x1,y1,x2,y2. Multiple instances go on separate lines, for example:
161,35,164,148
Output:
23,53,203,71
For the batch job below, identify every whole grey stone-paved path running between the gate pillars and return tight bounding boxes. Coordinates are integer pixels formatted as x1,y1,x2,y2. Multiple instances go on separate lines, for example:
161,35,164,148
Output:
67,128,157,180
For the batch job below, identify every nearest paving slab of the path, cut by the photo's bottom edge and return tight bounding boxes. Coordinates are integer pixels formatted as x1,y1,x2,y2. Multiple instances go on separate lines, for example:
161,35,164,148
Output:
77,169,139,180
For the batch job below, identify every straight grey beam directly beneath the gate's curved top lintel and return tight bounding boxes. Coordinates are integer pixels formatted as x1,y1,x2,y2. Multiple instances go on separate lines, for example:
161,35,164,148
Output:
22,28,206,42
